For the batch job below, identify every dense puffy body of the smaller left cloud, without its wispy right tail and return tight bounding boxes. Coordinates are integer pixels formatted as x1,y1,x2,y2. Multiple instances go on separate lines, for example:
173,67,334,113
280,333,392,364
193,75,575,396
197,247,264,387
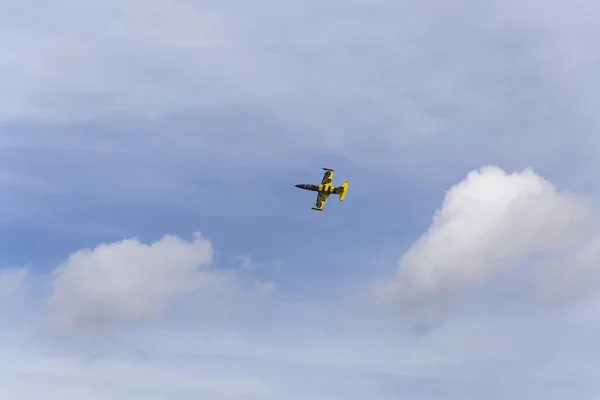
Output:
47,233,228,329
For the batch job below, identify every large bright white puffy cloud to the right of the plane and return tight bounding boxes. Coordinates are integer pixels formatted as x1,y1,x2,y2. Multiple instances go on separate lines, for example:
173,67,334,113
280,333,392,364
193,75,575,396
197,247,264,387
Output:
376,167,600,306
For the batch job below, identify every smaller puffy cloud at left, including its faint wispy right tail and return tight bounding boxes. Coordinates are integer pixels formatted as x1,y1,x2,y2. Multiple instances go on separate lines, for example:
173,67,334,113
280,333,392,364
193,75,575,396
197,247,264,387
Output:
44,233,275,334
